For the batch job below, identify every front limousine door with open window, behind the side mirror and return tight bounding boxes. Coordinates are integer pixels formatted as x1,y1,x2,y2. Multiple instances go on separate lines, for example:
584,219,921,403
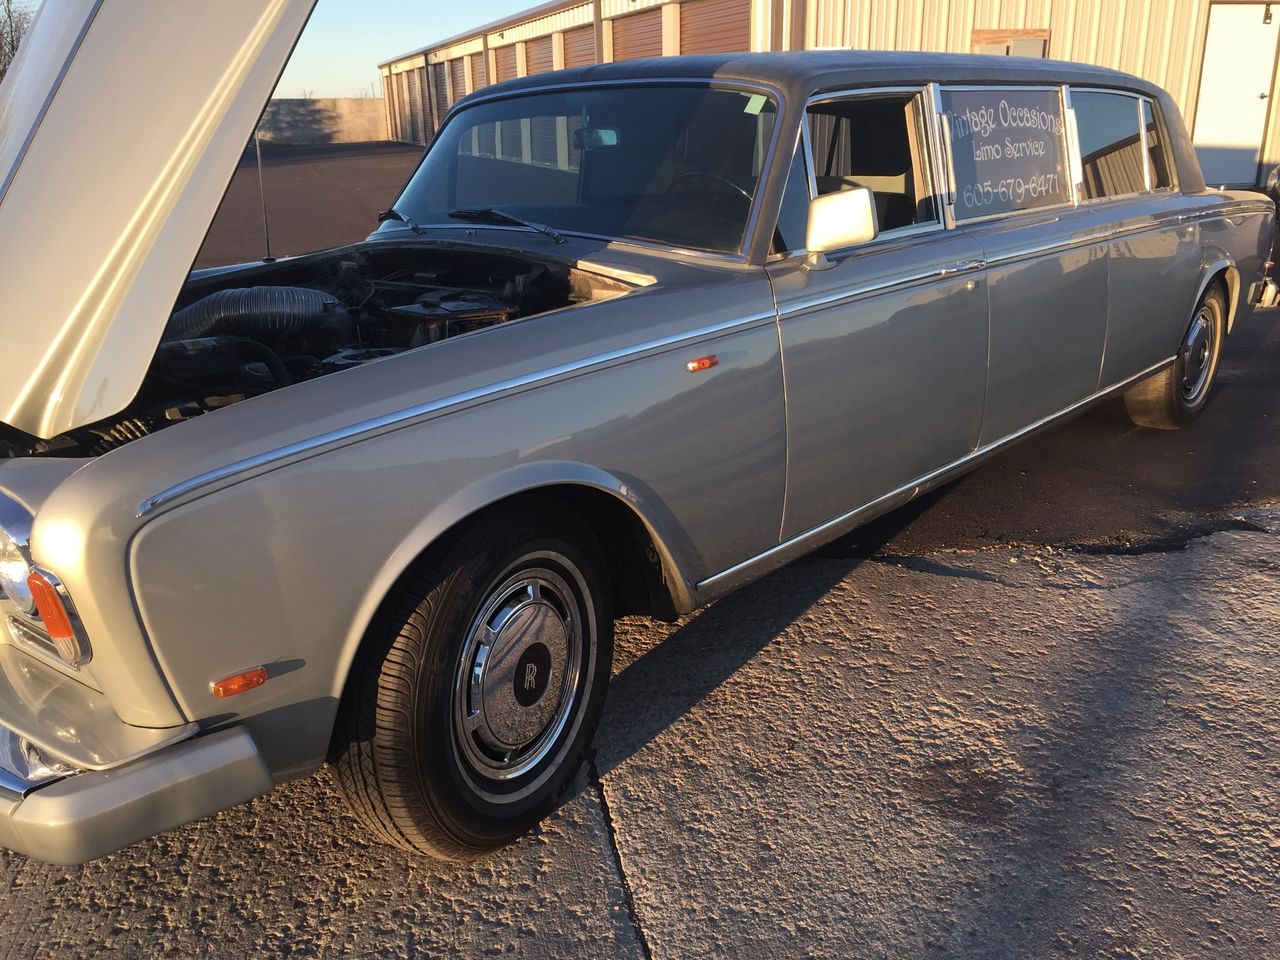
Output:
768,90,987,540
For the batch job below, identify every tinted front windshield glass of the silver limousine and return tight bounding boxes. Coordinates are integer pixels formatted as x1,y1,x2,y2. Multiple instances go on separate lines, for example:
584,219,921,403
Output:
383,86,777,252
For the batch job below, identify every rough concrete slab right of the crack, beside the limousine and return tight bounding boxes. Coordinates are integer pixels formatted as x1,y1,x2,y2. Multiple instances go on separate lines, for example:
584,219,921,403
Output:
599,512,1280,957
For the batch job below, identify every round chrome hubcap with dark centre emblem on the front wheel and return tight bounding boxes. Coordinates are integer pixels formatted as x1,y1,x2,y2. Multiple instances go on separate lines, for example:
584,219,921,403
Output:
453,567,582,780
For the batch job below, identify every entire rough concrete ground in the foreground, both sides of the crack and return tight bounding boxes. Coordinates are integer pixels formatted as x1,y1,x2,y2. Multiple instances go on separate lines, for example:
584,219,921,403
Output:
0,507,1280,957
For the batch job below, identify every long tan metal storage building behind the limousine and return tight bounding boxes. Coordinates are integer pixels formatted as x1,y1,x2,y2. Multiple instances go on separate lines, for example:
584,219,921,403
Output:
379,0,1280,184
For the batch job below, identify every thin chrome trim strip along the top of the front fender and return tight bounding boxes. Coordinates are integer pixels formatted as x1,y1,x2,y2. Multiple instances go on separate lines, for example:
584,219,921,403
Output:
137,311,777,518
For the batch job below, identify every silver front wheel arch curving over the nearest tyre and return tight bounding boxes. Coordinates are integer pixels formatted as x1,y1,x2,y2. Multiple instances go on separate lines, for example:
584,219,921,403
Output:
325,461,695,698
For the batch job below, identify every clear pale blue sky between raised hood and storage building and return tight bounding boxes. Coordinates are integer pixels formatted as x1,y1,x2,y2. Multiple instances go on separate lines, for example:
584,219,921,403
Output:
275,0,541,97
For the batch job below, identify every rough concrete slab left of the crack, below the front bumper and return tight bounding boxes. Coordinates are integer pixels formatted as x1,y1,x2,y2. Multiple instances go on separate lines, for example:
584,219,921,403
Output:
0,774,643,960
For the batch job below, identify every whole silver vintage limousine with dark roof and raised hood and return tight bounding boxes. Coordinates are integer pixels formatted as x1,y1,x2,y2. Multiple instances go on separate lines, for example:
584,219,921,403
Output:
0,0,1276,863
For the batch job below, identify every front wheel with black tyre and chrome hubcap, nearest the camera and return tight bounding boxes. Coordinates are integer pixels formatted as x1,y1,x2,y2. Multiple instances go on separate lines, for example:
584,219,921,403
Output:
332,508,613,860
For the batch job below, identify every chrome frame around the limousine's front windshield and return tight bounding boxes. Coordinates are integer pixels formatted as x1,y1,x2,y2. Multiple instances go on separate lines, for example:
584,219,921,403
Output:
396,77,790,264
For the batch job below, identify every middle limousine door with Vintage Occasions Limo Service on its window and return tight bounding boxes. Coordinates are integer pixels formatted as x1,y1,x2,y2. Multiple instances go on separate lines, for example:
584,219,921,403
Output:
938,86,1110,447
